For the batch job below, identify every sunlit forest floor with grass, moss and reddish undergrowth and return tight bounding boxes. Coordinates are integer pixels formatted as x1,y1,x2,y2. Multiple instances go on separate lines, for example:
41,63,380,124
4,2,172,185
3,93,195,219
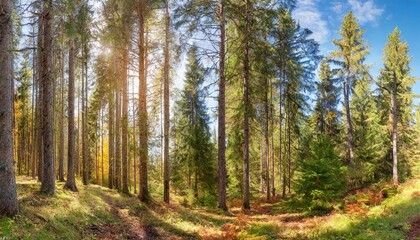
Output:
0,177,420,239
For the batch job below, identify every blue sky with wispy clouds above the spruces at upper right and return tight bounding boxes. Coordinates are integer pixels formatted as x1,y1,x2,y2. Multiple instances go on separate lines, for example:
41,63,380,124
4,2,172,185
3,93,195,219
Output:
294,0,420,98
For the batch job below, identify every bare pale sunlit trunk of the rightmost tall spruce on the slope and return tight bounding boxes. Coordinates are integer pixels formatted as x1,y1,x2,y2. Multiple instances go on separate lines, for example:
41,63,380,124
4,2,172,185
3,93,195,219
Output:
391,79,399,185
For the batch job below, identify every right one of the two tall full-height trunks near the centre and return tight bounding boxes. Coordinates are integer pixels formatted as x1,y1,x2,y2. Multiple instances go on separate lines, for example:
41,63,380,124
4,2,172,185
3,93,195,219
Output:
243,0,252,209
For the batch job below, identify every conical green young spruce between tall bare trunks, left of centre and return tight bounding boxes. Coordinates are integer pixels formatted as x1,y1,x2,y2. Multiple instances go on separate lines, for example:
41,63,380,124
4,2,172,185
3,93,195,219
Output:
173,47,216,201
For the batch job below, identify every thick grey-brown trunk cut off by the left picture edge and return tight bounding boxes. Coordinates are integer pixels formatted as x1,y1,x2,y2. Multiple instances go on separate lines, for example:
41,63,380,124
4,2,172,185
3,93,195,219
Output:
0,0,19,216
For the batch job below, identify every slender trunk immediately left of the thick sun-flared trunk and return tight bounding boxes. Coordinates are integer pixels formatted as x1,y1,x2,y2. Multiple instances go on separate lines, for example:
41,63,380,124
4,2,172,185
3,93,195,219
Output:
122,49,129,193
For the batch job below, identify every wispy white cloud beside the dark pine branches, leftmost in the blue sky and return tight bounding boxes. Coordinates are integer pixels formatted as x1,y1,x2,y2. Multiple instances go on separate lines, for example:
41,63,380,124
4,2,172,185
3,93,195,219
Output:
293,0,330,44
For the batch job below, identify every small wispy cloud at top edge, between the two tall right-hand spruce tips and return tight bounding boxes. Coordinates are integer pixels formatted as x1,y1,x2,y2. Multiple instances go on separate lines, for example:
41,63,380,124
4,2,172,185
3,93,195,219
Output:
348,0,384,24
